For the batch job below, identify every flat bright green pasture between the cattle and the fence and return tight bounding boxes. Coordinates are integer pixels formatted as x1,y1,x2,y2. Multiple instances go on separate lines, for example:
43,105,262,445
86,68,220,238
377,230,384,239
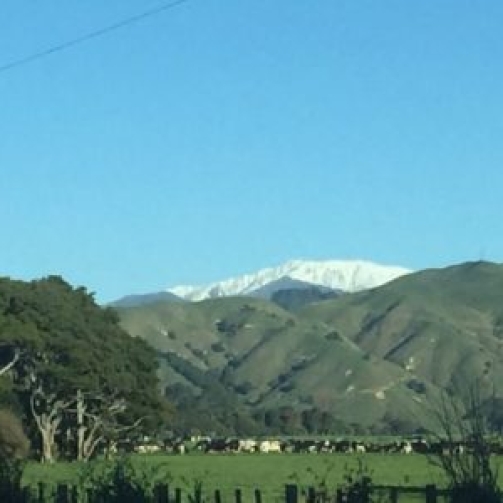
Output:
24,454,454,502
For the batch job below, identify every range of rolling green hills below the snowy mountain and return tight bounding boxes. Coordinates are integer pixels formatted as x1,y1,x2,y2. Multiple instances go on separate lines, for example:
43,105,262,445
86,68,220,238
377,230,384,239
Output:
119,262,503,431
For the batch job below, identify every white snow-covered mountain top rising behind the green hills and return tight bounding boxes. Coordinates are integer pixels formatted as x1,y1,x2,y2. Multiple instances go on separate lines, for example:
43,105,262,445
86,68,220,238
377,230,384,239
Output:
168,260,412,301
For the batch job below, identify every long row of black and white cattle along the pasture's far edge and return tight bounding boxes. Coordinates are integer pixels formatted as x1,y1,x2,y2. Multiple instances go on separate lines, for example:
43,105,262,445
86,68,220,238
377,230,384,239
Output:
132,437,503,455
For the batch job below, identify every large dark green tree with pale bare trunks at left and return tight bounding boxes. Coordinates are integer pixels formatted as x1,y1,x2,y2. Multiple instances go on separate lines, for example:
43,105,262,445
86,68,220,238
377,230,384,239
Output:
0,276,166,462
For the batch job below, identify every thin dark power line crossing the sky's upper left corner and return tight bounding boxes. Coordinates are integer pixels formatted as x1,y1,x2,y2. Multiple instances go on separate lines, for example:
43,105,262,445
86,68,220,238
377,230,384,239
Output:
0,0,189,73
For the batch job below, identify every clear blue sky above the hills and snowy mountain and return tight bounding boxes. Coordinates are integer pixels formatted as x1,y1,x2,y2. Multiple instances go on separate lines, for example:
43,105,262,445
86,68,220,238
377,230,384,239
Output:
0,0,503,302
